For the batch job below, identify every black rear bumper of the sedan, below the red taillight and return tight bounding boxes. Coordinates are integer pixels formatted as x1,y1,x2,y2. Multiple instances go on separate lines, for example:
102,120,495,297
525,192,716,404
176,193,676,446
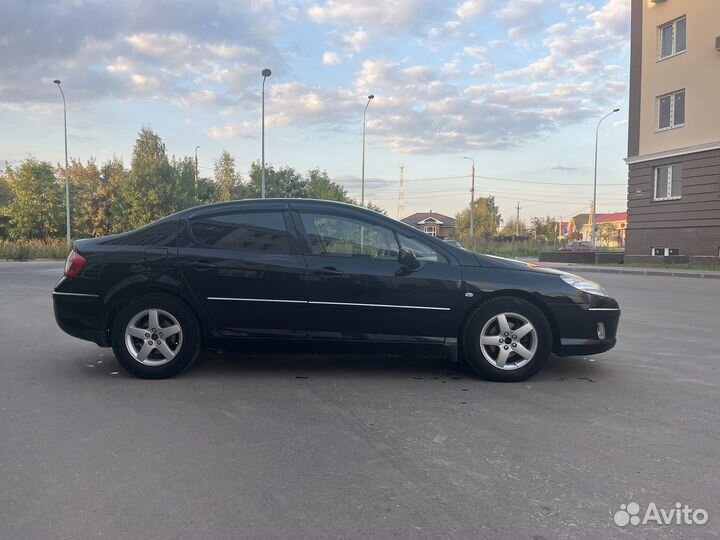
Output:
53,291,109,347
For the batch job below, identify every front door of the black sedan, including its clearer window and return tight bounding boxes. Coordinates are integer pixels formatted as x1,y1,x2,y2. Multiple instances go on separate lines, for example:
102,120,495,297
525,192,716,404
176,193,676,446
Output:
294,208,461,342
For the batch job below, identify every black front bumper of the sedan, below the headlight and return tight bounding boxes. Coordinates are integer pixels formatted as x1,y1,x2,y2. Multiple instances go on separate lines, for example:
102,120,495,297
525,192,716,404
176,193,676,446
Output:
551,301,620,356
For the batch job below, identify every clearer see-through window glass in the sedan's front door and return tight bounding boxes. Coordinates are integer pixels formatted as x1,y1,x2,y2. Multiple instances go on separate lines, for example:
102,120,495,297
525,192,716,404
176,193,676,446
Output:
301,213,399,260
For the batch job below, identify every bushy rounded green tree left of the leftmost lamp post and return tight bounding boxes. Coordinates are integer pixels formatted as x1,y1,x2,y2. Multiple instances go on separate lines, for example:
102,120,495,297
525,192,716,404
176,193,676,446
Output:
8,158,65,242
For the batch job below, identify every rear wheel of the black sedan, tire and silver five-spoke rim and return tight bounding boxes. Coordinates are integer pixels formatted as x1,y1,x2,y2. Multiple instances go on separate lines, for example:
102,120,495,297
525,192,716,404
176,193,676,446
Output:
111,294,201,379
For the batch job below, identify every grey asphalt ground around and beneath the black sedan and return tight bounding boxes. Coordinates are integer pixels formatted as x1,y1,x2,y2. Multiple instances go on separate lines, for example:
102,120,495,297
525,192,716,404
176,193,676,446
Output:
0,262,720,540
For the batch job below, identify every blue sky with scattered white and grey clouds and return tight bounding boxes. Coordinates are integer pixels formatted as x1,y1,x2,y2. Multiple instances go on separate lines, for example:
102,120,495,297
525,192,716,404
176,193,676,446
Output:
0,0,630,224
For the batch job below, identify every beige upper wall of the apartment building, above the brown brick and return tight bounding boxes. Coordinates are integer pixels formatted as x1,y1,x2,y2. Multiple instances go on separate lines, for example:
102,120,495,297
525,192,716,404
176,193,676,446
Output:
639,0,720,156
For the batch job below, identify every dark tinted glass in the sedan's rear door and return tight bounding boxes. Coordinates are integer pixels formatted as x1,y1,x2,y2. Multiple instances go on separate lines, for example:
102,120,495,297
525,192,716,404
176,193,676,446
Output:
190,212,291,252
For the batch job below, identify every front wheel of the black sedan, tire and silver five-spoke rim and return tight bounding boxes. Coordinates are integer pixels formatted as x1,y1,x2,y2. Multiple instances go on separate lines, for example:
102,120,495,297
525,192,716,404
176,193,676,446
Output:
462,296,553,382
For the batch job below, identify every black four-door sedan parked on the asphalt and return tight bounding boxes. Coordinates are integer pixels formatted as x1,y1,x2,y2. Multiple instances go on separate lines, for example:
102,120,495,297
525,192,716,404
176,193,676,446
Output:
53,199,620,381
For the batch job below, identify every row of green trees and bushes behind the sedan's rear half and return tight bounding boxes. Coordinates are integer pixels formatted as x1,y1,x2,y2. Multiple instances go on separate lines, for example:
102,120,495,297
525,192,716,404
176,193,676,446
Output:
0,128,384,255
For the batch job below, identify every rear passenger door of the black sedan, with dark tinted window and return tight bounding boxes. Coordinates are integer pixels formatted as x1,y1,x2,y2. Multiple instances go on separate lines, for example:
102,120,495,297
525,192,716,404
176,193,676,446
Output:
178,204,307,338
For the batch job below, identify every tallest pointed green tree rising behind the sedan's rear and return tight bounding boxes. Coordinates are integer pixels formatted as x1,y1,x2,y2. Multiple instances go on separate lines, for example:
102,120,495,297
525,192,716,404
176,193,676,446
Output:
123,127,177,228
